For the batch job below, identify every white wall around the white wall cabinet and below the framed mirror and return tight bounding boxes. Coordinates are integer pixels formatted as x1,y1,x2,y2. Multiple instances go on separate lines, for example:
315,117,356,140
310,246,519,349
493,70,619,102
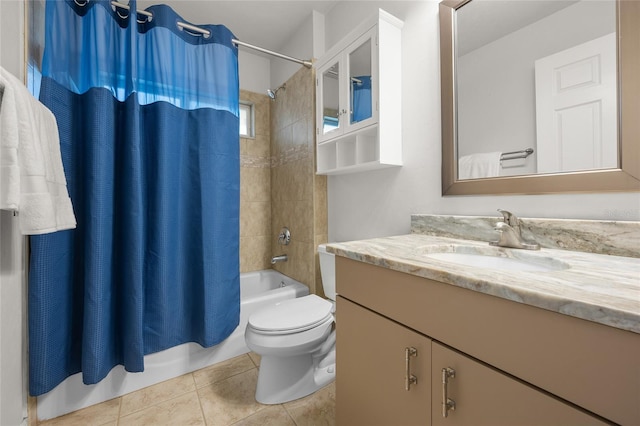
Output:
325,0,640,241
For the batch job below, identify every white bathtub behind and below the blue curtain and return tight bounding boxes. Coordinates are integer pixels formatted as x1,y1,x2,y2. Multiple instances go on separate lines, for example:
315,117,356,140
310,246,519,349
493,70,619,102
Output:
37,269,309,420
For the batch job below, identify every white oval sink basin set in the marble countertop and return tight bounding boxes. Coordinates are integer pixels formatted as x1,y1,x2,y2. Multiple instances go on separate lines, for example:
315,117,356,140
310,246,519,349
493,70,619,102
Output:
426,246,569,272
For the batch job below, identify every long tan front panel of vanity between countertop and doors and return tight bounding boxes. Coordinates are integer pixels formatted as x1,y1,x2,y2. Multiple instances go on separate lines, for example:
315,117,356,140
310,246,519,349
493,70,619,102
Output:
336,257,640,425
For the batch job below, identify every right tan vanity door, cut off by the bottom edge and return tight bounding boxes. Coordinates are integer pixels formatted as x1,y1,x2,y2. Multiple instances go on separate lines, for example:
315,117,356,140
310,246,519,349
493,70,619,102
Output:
431,342,606,426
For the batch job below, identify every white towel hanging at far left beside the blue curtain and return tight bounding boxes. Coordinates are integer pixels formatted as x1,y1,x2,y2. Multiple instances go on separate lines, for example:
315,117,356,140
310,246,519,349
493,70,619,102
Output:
0,67,76,235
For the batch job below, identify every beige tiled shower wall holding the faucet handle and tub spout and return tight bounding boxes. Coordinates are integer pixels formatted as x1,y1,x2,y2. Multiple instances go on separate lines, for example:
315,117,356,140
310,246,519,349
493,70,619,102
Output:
271,68,327,294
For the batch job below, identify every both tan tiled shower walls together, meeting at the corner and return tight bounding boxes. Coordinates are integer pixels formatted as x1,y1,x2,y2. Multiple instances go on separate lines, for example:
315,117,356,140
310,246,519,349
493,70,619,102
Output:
240,68,328,295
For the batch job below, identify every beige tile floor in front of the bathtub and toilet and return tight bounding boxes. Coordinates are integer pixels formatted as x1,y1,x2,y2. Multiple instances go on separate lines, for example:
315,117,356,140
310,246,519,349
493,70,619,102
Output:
37,353,335,426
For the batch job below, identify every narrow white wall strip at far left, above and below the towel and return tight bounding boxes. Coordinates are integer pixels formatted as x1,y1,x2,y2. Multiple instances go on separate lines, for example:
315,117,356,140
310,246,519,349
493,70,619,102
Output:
0,0,27,426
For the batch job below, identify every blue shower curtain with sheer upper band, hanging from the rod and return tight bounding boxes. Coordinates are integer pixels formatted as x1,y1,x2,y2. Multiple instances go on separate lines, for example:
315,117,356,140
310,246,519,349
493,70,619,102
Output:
29,0,240,395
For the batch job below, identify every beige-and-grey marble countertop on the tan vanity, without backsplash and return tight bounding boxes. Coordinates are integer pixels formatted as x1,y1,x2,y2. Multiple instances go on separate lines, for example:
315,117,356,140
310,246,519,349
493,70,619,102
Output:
327,234,640,334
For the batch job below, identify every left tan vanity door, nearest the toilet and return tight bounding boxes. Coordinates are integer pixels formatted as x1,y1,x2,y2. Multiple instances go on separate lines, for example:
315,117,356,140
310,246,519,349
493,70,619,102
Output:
336,297,431,426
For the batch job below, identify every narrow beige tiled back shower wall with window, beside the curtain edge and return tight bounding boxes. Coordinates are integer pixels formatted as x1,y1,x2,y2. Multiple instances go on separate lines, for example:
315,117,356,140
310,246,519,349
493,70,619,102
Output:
240,90,272,272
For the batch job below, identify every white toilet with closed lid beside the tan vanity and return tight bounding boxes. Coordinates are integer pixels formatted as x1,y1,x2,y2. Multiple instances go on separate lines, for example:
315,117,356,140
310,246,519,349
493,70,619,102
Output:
244,244,336,404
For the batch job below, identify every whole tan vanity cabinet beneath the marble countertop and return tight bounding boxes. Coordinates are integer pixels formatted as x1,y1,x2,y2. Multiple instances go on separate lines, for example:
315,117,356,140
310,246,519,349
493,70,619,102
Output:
336,256,640,426
